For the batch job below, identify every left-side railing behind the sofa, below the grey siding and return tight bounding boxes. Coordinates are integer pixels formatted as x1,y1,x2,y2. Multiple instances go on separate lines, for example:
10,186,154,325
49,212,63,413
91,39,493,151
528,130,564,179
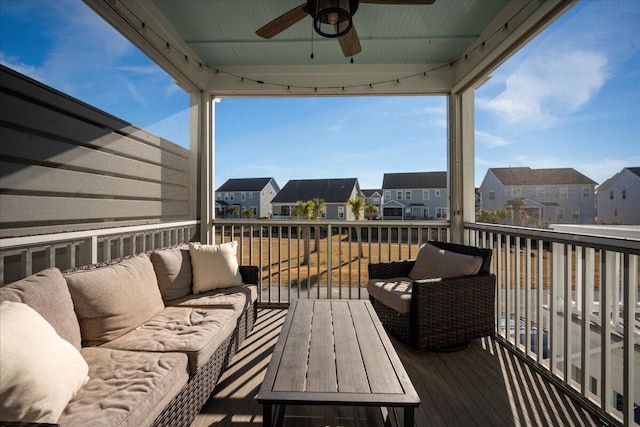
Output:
0,221,200,284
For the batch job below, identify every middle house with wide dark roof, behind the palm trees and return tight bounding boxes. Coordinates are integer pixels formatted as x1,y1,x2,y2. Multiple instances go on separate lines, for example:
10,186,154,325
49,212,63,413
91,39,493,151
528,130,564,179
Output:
271,178,362,220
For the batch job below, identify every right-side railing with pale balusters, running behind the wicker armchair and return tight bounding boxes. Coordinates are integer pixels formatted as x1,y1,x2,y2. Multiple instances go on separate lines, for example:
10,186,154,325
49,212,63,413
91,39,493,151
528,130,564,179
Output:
465,224,640,425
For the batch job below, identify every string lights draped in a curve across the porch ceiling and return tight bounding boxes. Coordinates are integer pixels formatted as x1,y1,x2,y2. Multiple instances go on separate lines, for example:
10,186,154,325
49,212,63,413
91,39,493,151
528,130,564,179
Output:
114,0,525,94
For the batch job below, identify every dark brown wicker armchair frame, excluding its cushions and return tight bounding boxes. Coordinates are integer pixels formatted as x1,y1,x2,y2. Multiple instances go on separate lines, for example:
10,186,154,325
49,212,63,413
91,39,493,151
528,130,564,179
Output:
368,242,496,351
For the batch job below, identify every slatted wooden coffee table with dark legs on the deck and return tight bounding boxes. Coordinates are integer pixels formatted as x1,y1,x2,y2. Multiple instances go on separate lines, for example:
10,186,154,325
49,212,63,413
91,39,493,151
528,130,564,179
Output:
258,300,420,426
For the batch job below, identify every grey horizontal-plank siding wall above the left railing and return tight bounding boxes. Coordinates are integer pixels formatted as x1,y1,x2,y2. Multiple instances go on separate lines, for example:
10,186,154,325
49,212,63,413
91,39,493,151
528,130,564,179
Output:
0,67,197,237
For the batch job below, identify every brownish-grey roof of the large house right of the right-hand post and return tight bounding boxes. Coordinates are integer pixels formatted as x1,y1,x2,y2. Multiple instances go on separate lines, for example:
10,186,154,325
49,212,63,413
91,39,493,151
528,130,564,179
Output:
489,167,597,186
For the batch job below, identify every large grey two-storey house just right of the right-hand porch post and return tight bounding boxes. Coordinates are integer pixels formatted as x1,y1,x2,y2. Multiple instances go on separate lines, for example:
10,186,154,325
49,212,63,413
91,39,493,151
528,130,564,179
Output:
480,167,596,226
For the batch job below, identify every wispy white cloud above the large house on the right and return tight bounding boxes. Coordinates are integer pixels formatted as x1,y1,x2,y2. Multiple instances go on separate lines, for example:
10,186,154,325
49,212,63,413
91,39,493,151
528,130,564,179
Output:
478,50,608,128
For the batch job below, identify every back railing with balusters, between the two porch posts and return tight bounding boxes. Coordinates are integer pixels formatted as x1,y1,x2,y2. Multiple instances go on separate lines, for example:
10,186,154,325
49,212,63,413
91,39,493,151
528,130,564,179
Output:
213,219,449,304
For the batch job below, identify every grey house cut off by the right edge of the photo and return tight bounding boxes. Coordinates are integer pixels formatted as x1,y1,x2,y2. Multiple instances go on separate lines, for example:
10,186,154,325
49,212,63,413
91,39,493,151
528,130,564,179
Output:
596,167,640,224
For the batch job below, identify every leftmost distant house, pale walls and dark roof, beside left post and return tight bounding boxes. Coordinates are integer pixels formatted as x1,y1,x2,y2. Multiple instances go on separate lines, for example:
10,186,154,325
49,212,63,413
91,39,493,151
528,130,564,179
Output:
216,178,280,218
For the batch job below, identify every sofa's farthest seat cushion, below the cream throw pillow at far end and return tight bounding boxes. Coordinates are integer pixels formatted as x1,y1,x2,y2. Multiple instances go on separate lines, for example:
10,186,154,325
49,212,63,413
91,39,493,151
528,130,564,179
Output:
166,285,258,317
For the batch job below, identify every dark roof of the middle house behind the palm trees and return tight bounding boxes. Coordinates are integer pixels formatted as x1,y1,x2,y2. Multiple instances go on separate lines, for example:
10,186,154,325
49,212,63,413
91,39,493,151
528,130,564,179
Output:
271,178,360,203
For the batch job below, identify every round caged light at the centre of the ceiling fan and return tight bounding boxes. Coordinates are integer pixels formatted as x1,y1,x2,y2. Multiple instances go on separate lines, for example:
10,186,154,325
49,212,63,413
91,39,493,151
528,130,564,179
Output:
311,0,357,38
